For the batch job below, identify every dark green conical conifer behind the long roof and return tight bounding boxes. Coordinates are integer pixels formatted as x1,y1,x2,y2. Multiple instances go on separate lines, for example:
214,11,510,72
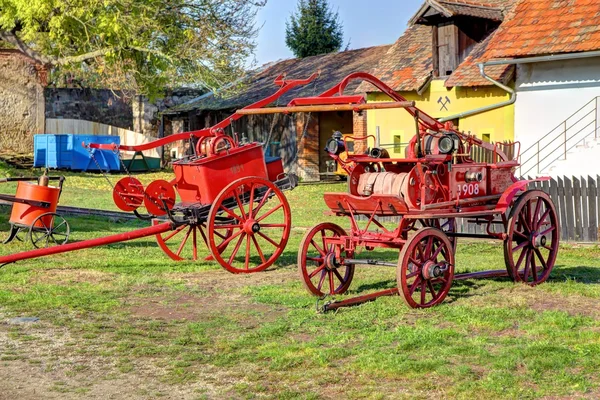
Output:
285,0,344,58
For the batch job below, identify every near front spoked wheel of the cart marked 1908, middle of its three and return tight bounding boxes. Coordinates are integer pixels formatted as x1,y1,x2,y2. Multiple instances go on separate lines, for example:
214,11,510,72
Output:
396,228,454,308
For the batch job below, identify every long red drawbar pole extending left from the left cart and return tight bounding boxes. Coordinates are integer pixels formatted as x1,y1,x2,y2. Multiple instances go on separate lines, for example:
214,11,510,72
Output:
0,222,174,265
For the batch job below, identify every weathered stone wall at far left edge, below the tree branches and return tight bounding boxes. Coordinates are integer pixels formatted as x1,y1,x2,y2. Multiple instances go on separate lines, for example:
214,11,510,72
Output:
0,50,46,153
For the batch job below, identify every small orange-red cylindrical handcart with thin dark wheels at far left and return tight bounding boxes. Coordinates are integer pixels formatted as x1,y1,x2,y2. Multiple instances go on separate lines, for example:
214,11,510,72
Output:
0,175,70,248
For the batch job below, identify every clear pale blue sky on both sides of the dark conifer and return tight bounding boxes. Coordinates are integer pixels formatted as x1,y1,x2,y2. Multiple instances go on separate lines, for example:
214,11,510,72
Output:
255,0,423,65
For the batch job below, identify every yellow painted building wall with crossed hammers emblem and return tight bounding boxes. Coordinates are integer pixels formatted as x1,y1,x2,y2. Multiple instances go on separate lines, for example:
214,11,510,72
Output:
367,79,515,156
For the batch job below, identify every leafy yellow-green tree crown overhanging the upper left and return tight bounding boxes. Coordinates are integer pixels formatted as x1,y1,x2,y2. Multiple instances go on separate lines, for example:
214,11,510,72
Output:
0,0,266,96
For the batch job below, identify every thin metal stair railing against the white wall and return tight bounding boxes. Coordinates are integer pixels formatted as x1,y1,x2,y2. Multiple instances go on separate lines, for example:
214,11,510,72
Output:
519,96,600,176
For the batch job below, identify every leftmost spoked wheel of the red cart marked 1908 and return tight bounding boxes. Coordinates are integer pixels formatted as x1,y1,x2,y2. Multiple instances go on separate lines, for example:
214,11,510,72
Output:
298,222,354,296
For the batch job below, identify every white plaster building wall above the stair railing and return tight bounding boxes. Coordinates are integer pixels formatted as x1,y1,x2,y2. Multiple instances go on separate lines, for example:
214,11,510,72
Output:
515,57,600,175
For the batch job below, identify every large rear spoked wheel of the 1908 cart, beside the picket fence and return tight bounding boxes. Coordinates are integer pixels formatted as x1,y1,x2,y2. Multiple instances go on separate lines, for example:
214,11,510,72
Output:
504,190,560,286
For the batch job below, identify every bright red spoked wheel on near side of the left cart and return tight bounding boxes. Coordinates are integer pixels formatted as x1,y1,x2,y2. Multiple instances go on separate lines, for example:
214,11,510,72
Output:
207,177,292,274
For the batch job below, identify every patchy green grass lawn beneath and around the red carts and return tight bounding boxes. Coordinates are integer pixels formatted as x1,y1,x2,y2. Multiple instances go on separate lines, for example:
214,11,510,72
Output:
0,161,600,399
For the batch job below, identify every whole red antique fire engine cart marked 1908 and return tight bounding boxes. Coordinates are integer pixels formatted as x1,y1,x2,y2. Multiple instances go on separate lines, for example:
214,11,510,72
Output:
288,73,559,310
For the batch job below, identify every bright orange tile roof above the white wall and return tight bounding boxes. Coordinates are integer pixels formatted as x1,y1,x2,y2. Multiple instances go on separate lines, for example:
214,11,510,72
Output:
486,0,600,58
